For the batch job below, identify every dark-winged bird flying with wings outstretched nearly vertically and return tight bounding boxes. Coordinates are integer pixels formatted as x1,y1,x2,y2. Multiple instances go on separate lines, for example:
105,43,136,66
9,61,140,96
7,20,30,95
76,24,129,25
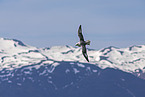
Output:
76,25,90,62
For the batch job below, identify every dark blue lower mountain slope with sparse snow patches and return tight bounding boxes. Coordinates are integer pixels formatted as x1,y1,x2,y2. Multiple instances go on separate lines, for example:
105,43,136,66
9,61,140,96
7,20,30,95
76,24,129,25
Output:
0,62,145,97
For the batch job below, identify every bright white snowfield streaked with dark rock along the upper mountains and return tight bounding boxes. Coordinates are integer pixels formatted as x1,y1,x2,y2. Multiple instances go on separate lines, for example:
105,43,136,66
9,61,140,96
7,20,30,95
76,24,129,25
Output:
0,38,145,73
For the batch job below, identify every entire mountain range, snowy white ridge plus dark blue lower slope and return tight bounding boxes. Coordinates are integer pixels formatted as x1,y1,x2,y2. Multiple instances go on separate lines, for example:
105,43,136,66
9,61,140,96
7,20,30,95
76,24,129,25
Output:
0,38,145,97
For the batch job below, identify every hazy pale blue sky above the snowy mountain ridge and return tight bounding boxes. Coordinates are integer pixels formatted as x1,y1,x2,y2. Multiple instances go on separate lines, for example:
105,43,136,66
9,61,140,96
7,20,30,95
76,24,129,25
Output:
0,0,145,49
